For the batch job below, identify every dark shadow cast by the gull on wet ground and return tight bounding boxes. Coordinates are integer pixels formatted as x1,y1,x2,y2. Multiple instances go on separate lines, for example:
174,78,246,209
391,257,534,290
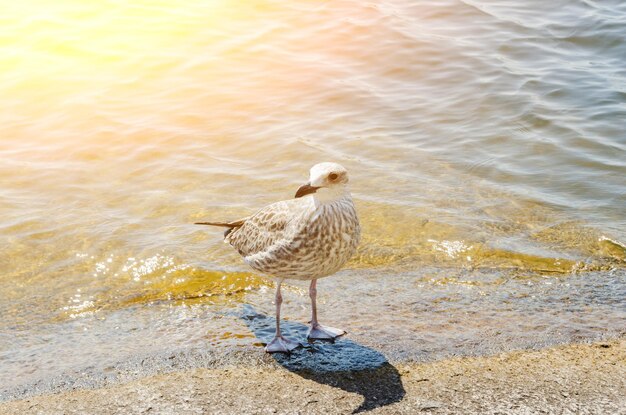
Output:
241,305,406,413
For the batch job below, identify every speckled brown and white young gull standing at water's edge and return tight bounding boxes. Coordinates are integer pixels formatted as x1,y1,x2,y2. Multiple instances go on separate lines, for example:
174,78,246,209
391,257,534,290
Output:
196,162,361,353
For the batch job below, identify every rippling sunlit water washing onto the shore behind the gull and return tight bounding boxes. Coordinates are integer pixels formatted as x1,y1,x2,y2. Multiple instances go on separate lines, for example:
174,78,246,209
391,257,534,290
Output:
0,0,626,398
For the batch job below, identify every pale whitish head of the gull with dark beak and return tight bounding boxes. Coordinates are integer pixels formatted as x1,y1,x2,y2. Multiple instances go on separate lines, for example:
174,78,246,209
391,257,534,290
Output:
296,163,348,199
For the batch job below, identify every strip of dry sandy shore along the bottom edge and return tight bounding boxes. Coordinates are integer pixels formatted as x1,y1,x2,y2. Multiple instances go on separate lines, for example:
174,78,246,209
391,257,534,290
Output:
0,339,626,414
